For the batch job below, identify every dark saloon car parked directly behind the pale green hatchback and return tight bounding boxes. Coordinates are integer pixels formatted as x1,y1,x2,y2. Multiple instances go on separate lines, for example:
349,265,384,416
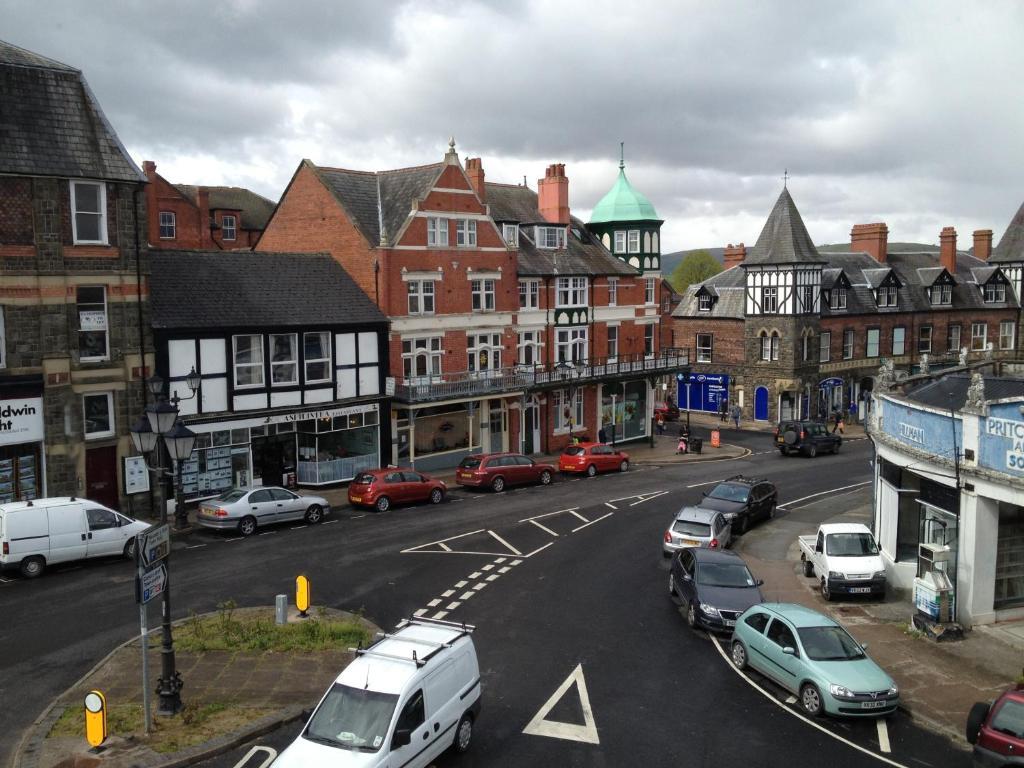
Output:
669,548,764,632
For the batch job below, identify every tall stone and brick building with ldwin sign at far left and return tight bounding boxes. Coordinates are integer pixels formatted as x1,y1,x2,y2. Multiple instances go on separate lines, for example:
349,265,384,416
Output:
0,42,152,509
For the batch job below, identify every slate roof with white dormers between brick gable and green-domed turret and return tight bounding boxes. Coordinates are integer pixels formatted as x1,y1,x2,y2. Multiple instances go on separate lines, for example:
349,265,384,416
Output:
485,183,638,276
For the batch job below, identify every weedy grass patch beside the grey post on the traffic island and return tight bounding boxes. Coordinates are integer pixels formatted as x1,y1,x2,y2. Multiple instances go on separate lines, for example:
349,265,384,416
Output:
174,601,371,652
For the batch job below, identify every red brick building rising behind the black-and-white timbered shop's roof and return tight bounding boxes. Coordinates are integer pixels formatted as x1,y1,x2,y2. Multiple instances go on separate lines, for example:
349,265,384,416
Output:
142,160,274,251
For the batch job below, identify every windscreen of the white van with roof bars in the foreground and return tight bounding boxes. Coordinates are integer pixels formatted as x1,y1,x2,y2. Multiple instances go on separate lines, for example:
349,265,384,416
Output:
302,683,398,752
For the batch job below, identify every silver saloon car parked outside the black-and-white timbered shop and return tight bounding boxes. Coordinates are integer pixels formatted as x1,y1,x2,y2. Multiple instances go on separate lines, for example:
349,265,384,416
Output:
196,485,331,536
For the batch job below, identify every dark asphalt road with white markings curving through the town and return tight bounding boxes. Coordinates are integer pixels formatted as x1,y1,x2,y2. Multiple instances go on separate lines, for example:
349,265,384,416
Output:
0,433,968,768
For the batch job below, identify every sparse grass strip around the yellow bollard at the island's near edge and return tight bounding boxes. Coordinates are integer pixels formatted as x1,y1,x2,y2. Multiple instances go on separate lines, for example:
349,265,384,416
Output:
47,702,272,754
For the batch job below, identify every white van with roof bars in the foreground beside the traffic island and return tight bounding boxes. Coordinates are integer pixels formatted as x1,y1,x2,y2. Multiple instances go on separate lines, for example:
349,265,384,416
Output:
273,618,480,768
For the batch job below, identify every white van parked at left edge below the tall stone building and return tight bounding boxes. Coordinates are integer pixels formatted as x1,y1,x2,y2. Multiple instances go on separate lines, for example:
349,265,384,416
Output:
0,496,150,579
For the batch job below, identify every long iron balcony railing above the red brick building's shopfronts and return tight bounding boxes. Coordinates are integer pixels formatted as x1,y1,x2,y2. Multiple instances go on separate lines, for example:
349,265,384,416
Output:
394,347,690,402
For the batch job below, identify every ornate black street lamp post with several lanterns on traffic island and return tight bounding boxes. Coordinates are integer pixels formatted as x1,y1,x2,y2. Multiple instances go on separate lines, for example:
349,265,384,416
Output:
129,368,200,716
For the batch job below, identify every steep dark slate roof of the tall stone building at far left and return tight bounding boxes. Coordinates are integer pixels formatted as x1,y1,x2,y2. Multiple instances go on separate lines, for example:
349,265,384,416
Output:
0,41,145,182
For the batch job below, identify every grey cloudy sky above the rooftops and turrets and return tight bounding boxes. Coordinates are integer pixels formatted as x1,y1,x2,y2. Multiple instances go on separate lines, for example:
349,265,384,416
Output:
0,0,1024,251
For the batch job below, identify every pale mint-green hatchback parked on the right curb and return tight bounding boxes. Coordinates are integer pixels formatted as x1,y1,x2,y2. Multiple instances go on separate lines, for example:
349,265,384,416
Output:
732,603,899,717
